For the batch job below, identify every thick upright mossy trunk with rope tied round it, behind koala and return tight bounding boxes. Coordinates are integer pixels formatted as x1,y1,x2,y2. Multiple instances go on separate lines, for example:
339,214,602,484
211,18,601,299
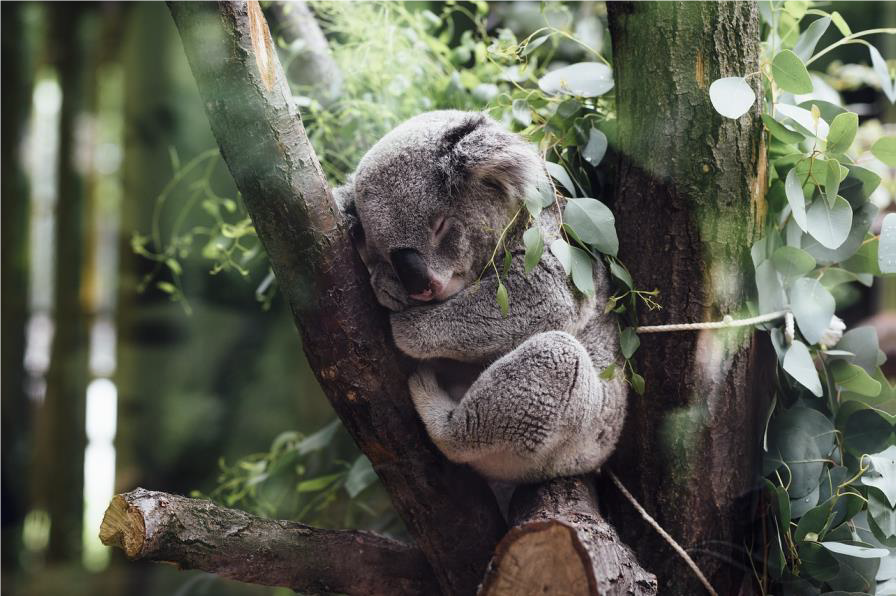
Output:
607,0,766,594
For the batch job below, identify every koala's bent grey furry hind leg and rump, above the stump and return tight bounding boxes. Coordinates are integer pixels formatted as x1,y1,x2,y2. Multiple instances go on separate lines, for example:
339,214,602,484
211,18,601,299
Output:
410,331,626,482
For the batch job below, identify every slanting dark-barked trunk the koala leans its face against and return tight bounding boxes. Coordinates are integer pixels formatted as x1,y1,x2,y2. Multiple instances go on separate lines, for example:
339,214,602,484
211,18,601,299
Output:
168,0,505,594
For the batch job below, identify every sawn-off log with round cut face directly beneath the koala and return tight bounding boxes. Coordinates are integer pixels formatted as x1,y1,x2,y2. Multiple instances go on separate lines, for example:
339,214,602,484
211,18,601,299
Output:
479,477,657,596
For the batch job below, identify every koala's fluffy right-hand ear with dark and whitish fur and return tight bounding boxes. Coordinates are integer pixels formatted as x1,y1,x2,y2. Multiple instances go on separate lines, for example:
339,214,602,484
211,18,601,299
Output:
438,113,544,199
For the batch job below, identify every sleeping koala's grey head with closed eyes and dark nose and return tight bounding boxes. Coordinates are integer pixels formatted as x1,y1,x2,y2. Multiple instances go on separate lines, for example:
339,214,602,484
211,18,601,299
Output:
339,111,543,310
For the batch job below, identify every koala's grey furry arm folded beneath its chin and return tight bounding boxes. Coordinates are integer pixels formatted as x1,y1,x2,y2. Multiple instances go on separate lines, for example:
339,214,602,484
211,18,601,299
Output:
392,253,586,362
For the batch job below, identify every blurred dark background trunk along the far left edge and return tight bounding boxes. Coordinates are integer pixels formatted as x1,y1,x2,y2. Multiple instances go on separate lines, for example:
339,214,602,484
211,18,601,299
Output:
0,0,31,583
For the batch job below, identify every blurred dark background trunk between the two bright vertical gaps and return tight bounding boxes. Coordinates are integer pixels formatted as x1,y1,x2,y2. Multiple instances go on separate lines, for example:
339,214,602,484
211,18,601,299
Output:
38,1,93,561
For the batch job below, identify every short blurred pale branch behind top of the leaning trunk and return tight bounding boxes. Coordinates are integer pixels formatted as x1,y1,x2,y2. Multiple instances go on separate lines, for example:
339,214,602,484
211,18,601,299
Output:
266,0,342,103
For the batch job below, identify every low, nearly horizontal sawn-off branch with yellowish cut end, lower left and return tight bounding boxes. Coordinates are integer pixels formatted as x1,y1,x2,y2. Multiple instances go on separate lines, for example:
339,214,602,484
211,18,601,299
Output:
100,488,438,596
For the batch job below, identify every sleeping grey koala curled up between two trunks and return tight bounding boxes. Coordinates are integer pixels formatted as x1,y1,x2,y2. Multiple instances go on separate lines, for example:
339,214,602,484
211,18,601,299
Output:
336,110,627,483
